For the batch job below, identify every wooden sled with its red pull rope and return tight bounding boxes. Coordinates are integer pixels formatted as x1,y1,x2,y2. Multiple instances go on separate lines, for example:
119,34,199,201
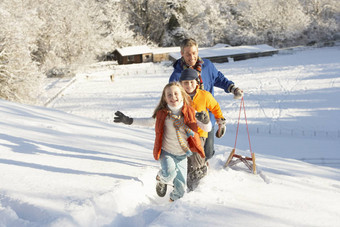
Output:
224,98,256,174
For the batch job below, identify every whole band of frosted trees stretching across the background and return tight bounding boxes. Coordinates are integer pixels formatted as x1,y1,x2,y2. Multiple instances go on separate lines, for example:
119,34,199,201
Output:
0,0,340,103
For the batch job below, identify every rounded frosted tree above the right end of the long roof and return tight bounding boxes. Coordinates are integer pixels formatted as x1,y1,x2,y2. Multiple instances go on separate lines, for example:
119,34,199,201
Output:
232,0,309,46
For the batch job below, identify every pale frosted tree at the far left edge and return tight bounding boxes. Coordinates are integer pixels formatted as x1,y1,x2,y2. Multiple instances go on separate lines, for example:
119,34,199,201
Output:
0,0,42,102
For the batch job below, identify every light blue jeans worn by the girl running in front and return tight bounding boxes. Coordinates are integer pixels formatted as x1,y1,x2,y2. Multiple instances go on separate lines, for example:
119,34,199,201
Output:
159,150,187,200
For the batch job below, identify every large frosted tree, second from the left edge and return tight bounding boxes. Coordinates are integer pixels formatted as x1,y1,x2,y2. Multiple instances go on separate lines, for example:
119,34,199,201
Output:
34,0,100,71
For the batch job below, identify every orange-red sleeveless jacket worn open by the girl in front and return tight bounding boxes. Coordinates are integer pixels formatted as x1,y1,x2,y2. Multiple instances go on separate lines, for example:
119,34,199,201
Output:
153,103,205,160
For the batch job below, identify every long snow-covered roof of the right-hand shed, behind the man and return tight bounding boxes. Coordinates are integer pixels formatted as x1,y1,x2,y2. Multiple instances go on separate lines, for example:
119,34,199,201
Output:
170,44,277,59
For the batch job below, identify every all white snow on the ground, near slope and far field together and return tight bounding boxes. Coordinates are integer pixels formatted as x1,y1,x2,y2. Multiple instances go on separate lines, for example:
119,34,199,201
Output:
0,47,340,226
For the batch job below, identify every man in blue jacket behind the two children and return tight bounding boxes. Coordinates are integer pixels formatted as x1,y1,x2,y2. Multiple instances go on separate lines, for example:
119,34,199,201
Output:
169,39,243,160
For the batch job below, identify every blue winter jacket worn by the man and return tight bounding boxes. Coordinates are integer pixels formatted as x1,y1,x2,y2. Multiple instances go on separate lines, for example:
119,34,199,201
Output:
169,59,234,125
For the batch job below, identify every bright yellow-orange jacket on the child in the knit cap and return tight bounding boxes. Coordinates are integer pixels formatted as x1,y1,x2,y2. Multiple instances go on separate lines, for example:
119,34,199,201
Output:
191,86,223,138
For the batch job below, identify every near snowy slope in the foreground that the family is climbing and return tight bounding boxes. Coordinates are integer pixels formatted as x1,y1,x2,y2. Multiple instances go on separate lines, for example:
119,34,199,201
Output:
0,97,340,226
